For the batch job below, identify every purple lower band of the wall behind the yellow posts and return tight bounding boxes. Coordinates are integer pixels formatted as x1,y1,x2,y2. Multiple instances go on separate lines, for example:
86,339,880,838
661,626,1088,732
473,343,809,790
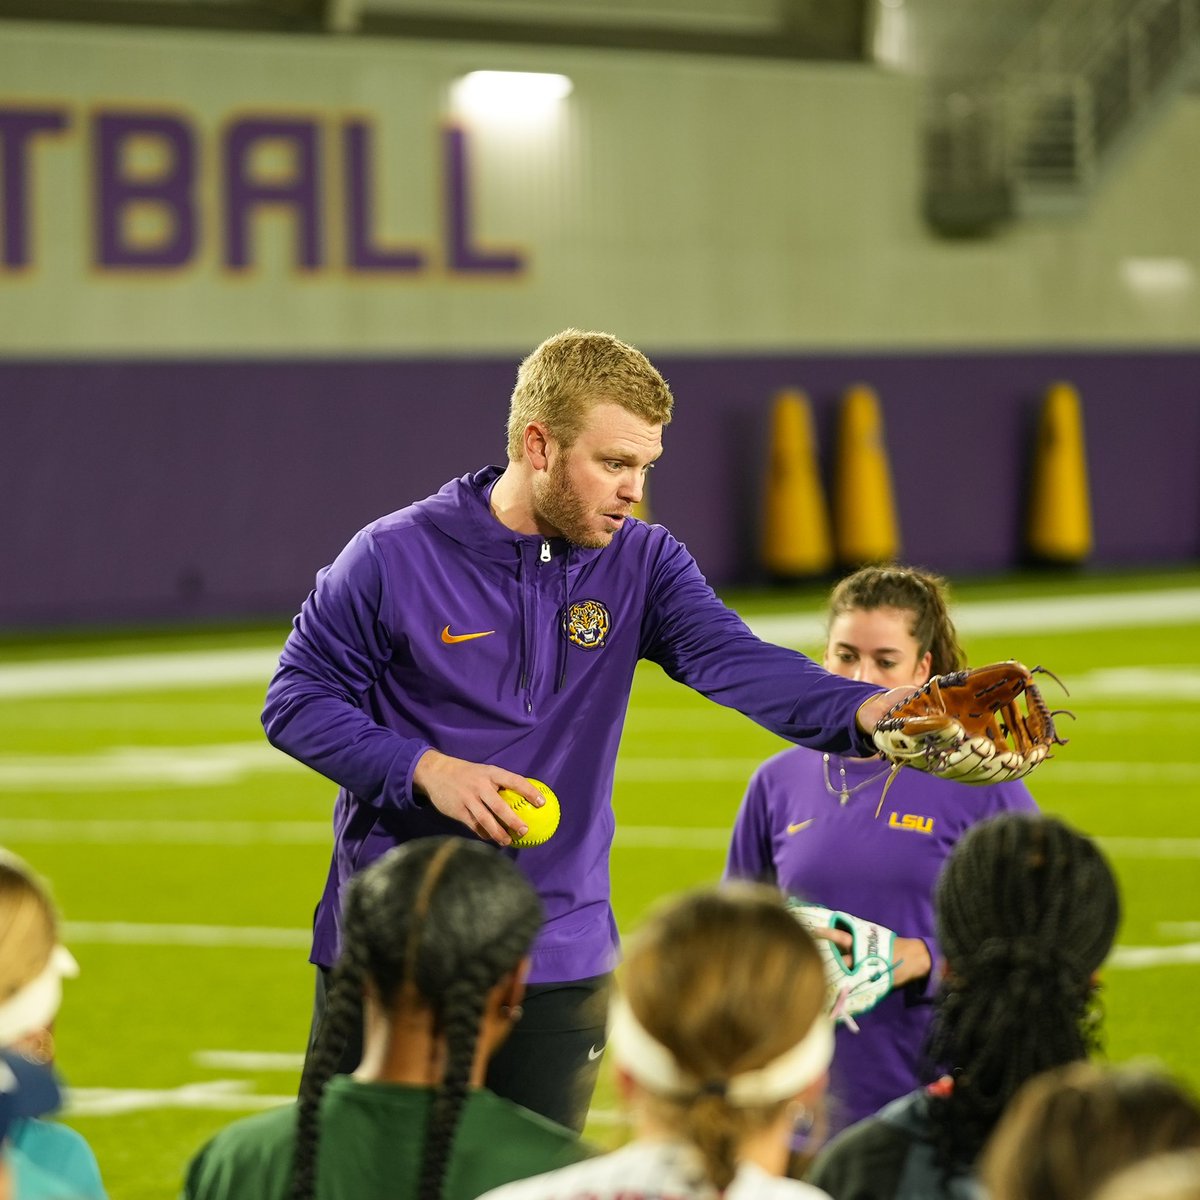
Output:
0,350,1200,628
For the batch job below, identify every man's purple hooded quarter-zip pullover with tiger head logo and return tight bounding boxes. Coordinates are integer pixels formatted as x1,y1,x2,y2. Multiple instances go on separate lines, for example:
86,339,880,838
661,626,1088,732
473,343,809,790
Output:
263,467,880,983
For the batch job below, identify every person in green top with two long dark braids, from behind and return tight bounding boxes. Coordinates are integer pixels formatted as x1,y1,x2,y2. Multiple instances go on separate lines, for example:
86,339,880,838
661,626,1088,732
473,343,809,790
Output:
184,838,589,1200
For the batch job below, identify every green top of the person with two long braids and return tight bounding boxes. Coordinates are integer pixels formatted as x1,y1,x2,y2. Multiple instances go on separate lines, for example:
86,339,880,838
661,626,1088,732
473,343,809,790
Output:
182,1075,594,1200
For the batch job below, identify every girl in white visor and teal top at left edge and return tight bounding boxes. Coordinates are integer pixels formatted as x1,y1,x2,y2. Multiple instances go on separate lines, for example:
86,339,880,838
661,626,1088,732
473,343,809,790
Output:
0,850,106,1200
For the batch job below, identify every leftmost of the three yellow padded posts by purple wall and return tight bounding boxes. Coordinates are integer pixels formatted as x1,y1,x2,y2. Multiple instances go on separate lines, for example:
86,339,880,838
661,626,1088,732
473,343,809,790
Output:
762,390,833,580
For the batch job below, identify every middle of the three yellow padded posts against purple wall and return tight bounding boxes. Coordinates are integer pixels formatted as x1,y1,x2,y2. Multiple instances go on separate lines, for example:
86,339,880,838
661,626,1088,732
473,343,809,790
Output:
834,384,900,566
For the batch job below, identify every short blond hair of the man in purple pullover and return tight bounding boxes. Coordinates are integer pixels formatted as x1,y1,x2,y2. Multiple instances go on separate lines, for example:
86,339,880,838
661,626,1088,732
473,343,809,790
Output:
509,329,674,462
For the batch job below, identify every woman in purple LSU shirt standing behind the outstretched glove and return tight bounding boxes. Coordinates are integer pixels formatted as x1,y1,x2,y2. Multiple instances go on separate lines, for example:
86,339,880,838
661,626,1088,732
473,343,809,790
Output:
725,564,1037,1132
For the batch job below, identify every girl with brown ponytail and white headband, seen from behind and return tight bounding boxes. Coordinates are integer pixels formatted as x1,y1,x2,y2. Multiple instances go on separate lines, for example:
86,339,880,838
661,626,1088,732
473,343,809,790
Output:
477,883,833,1200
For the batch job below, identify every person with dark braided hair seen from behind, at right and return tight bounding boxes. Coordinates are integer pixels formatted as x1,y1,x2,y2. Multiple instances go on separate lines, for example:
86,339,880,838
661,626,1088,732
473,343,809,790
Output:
809,812,1121,1200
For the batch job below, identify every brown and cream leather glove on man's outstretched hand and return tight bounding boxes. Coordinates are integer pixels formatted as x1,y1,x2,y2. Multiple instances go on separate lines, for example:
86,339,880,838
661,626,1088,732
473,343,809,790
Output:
874,659,1067,784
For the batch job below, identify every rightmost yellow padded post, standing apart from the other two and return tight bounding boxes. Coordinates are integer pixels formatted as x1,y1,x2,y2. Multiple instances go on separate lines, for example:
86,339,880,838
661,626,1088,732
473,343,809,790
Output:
1028,383,1092,563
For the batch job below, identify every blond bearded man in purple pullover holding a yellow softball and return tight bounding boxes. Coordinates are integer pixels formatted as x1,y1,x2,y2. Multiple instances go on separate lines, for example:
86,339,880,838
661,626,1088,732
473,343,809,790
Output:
263,329,907,1128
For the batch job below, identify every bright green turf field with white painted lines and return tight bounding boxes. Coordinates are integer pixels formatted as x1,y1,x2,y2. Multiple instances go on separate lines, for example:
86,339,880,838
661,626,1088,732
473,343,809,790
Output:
0,571,1200,1200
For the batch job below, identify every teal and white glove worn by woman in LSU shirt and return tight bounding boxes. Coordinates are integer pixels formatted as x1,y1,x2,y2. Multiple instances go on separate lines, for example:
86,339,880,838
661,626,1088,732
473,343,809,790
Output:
787,896,898,1032
